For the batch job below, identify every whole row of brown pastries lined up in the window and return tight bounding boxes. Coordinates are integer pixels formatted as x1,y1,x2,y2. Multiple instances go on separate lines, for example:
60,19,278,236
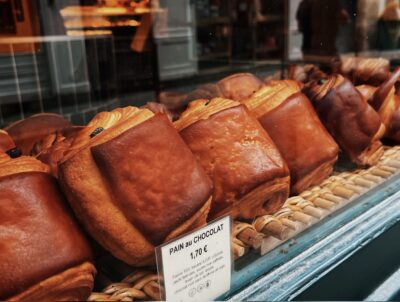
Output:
0,59,400,300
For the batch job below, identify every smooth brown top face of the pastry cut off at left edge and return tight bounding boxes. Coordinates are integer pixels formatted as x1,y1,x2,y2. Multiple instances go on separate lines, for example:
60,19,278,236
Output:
0,172,91,300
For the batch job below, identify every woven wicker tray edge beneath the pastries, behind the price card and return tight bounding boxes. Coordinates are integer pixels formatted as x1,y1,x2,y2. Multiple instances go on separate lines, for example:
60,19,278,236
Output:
89,146,400,301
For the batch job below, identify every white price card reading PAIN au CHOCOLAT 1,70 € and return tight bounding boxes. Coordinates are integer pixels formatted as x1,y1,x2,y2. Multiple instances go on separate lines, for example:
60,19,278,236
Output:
157,216,232,301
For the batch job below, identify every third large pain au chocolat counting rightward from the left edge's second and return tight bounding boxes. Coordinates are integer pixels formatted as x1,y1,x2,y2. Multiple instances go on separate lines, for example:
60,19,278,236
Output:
243,80,338,194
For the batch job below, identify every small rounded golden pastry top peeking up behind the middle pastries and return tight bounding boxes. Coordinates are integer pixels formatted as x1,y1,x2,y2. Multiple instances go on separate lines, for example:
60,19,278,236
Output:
217,73,263,101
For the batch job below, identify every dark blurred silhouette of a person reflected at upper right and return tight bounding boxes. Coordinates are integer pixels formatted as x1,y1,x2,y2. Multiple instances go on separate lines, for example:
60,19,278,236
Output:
296,0,349,59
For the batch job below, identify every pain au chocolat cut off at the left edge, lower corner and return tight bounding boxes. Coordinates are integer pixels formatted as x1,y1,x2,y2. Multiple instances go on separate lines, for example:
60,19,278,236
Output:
0,152,95,301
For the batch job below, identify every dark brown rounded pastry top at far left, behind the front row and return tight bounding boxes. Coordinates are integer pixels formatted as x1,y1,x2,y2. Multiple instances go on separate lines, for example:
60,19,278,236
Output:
5,113,72,155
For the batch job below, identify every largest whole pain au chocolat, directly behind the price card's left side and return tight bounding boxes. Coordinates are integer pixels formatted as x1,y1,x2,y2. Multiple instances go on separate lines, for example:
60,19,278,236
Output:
58,107,212,266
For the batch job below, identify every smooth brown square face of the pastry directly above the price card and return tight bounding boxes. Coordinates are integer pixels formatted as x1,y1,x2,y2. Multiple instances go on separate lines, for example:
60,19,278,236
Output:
92,115,211,245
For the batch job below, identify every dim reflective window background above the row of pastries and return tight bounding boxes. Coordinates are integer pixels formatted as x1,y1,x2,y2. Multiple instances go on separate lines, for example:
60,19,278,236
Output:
0,0,400,127
